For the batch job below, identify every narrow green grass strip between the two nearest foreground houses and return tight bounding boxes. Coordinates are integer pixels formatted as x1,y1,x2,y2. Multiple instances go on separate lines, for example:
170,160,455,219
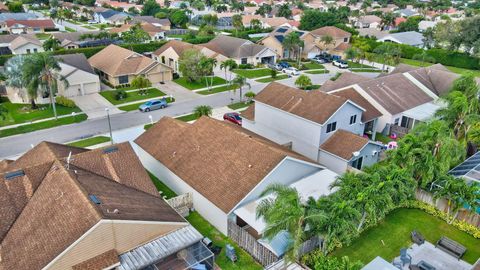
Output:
187,212,263,270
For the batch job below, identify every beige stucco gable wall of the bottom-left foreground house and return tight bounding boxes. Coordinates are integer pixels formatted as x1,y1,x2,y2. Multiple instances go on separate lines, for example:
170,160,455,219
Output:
44,220,187,270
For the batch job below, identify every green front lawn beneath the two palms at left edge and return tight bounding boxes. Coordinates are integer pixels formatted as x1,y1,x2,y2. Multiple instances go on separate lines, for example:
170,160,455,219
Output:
0,99,81,126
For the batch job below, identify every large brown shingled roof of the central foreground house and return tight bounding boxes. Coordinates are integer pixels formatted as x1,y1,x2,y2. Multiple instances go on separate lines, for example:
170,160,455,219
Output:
135,117,307,213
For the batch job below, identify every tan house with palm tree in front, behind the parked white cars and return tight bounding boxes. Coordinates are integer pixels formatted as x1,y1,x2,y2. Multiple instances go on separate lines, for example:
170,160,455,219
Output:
258,26,322,58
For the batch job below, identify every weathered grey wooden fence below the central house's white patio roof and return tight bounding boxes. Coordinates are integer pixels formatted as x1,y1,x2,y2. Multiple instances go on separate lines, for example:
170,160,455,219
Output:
228,220,278,266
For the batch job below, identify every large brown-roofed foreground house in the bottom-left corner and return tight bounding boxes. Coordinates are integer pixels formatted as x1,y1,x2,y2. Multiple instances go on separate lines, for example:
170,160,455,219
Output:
0,142,214,270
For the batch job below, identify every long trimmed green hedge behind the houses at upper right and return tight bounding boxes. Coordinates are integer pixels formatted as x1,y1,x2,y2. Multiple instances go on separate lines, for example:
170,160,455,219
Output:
353,37,480,69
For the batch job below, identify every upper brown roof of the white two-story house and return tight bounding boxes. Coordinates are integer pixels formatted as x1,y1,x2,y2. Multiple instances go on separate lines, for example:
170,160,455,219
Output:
255,82,347,124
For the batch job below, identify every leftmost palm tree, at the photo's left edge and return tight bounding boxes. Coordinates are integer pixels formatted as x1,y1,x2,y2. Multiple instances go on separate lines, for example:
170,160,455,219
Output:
4,55,38,109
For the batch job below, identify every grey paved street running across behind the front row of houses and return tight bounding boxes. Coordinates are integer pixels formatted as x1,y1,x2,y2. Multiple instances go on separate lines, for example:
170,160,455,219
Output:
0,67,378,159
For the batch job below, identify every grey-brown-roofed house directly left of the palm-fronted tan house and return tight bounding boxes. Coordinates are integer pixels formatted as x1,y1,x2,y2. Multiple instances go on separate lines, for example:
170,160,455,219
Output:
201,35,277,65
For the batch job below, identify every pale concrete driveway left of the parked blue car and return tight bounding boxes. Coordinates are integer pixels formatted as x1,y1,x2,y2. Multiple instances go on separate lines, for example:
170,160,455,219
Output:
71,93,123,119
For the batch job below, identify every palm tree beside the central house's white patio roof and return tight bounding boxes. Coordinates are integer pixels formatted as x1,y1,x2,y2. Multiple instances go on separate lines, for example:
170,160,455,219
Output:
256,184,324,261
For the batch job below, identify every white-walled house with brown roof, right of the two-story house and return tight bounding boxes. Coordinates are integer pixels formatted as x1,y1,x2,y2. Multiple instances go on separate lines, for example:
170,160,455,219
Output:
320,64,459,135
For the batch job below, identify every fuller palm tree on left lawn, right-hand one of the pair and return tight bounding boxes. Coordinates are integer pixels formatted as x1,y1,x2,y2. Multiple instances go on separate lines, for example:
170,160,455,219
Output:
22,53,68,119
